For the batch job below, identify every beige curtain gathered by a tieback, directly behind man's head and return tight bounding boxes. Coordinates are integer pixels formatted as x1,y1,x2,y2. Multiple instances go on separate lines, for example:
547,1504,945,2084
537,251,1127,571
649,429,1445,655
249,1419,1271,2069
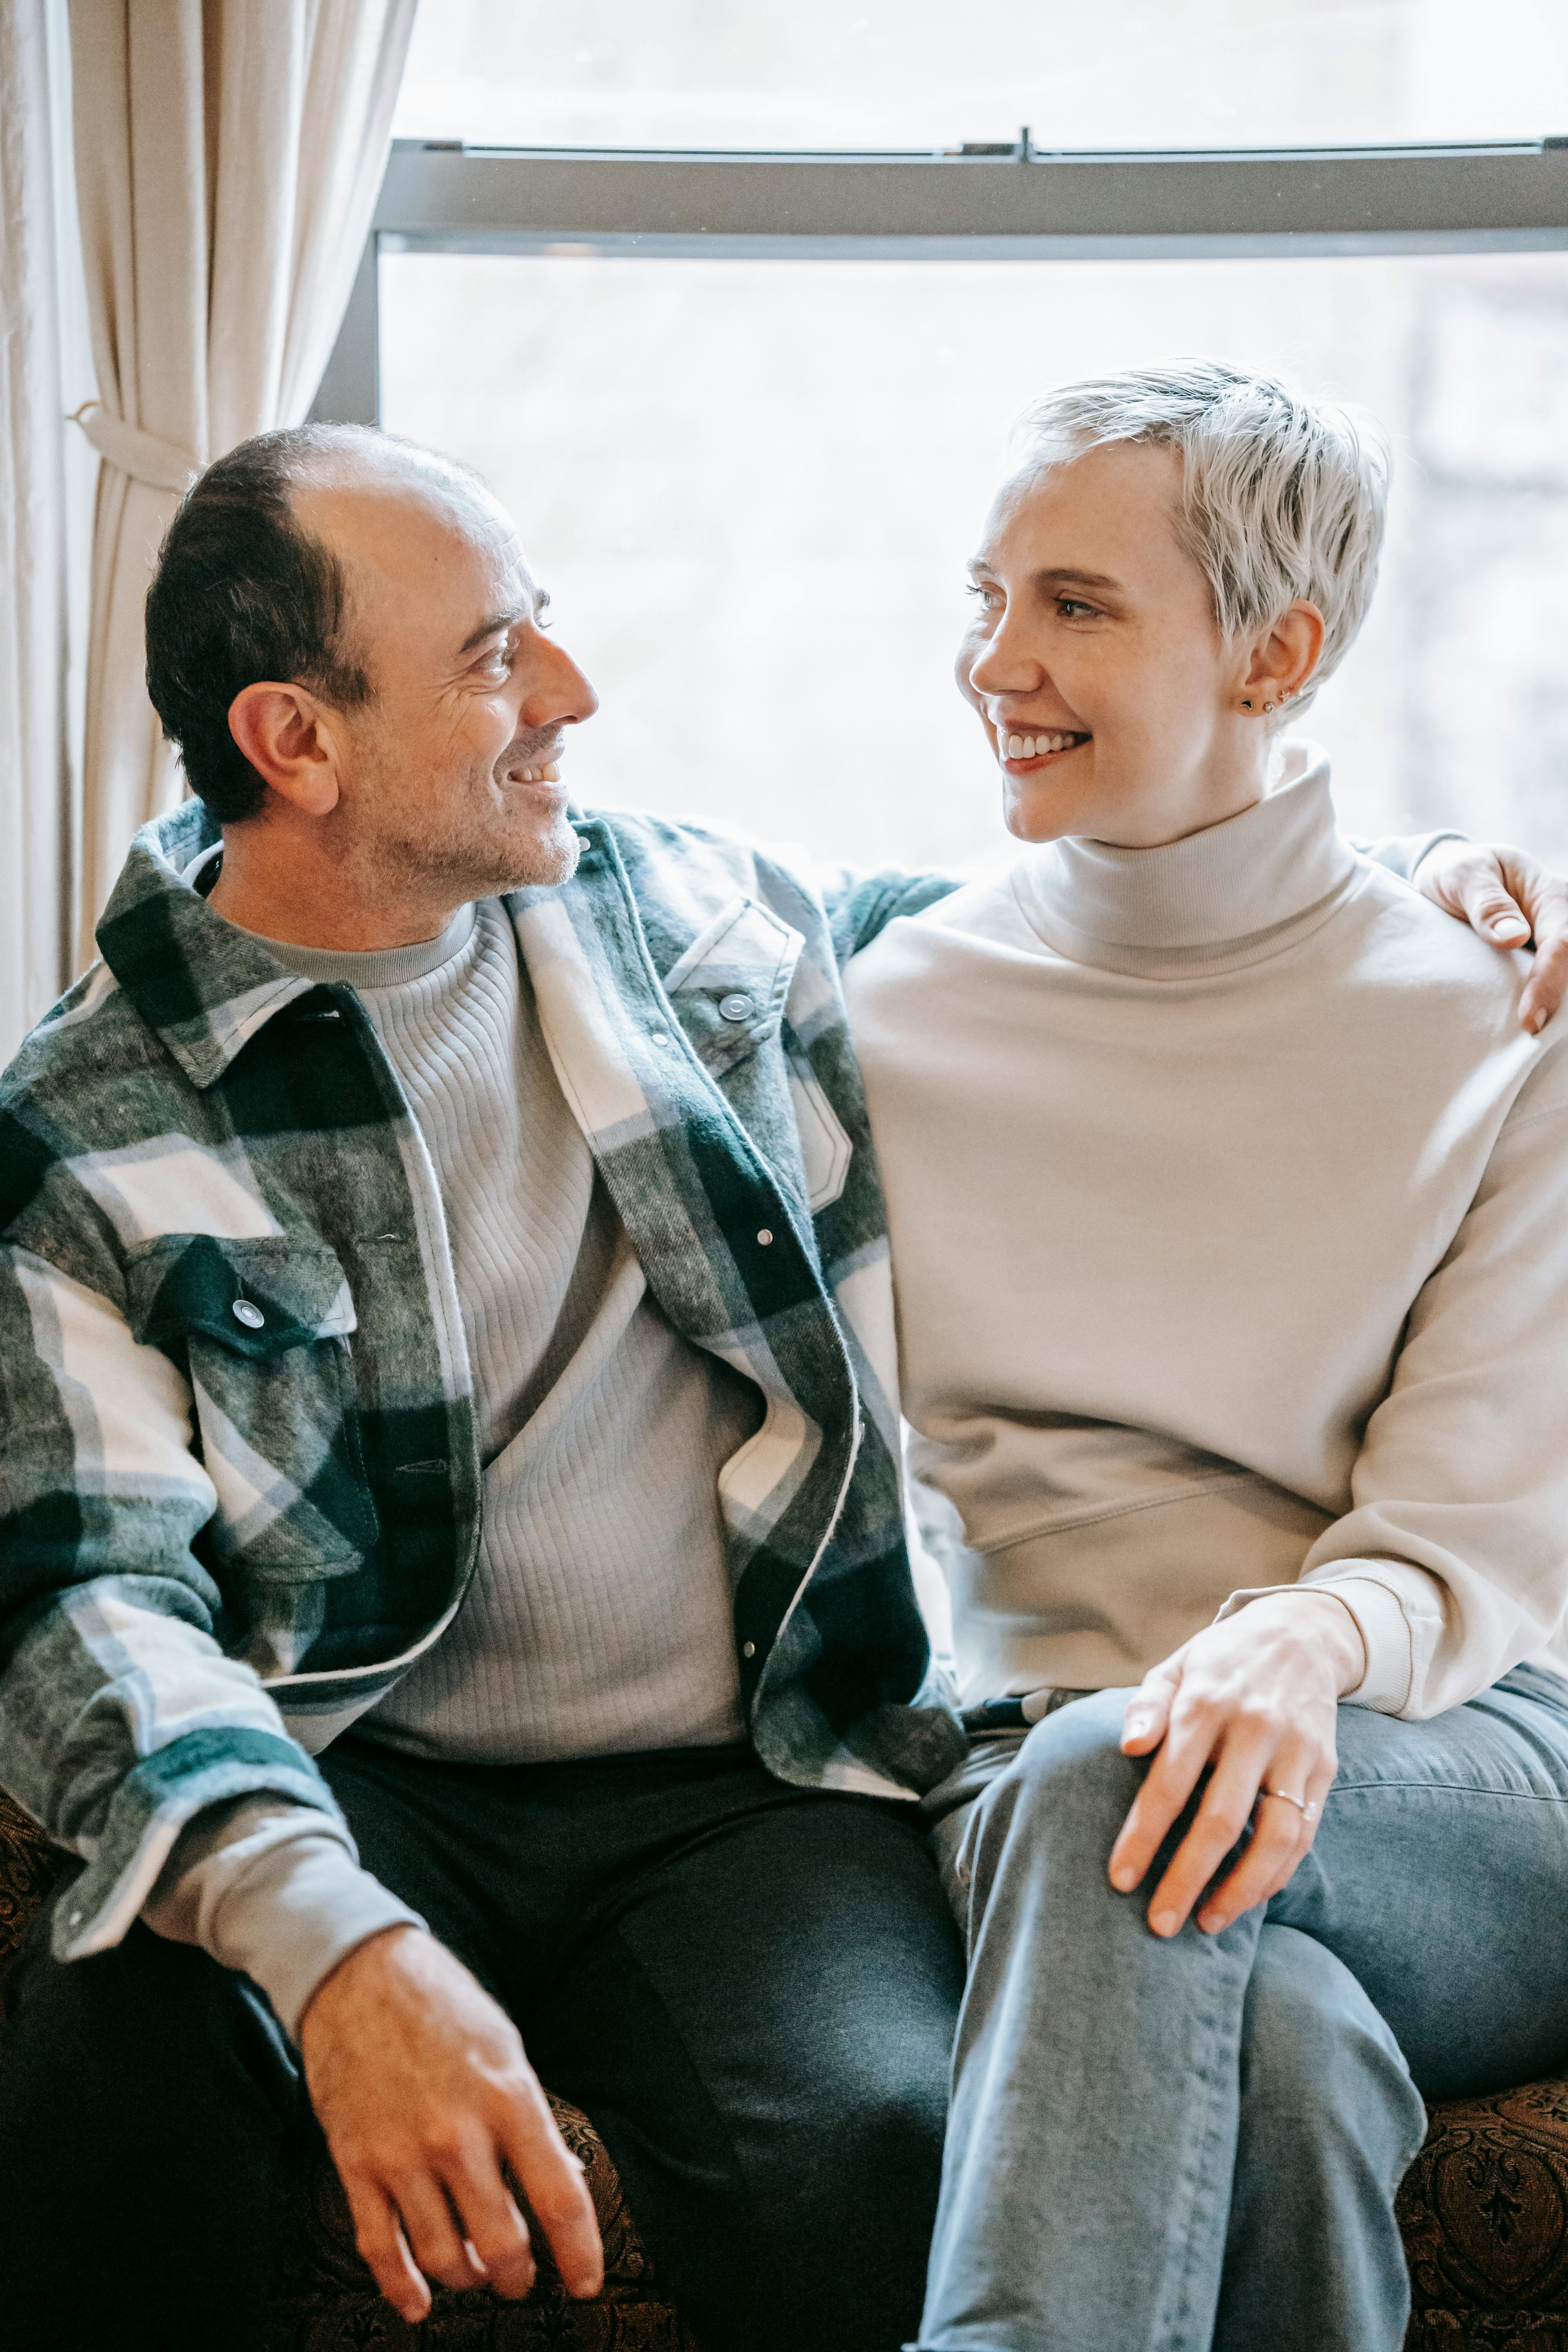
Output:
71,0,414,962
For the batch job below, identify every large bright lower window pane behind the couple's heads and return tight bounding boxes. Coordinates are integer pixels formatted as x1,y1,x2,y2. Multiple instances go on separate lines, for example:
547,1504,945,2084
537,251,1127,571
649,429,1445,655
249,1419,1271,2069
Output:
381,254,1568,866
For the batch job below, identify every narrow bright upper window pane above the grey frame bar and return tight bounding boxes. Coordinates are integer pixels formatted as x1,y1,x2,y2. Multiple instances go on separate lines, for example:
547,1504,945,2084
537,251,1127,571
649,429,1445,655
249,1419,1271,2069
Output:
397,0,1568,148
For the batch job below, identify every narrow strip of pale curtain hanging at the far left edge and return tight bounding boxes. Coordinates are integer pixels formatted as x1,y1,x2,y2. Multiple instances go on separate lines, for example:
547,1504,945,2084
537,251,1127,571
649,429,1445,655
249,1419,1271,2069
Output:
0,0,71,1063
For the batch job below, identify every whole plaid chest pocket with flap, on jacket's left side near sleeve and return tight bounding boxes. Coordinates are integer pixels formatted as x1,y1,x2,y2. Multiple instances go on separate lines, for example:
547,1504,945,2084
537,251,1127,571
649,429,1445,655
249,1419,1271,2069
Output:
127,1232,379,1583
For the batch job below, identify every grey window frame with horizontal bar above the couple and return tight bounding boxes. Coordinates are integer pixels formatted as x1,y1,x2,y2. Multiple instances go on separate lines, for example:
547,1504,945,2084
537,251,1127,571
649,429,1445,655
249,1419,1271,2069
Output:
310,132,1568,423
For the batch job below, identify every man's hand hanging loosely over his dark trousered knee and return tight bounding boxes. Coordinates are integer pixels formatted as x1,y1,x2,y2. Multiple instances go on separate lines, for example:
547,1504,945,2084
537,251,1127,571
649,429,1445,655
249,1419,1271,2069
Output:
299,1926,604,2324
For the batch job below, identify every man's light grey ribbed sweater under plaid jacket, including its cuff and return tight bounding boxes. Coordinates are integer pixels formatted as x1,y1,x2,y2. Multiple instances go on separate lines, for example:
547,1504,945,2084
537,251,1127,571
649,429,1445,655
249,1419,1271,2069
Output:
143,901,762,2030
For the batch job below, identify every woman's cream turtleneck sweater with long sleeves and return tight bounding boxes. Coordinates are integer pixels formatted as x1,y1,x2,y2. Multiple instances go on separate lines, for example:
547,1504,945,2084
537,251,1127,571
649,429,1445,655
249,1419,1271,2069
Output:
849,746,1568,1717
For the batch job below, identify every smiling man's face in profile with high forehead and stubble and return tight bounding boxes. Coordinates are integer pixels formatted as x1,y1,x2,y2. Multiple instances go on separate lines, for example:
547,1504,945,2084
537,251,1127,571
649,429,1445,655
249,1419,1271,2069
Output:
294,459,597,903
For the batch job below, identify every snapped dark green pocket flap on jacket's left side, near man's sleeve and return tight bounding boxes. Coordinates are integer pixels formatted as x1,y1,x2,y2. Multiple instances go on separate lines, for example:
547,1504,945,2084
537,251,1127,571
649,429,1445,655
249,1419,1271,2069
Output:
127,1232,358,1357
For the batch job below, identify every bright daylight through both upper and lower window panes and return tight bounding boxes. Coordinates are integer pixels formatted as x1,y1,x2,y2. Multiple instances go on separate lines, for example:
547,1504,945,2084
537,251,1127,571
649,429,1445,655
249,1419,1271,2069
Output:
381,0,1568,863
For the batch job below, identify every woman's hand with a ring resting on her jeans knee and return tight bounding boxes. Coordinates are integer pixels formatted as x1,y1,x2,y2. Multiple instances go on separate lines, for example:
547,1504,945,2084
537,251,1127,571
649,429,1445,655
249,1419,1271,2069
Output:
1110,1592,1366,1936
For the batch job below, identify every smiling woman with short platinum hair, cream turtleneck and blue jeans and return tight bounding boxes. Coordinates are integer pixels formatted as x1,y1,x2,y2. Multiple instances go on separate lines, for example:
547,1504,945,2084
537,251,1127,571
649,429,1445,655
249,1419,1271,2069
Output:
851,365,1568,2352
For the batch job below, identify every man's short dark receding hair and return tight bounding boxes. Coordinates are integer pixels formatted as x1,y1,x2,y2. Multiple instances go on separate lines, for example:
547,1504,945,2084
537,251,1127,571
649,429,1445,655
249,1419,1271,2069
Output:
146,426,379,826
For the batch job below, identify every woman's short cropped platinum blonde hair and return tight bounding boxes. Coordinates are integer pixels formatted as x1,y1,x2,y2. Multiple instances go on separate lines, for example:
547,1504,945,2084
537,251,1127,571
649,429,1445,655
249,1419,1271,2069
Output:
1013,360,1389,715
